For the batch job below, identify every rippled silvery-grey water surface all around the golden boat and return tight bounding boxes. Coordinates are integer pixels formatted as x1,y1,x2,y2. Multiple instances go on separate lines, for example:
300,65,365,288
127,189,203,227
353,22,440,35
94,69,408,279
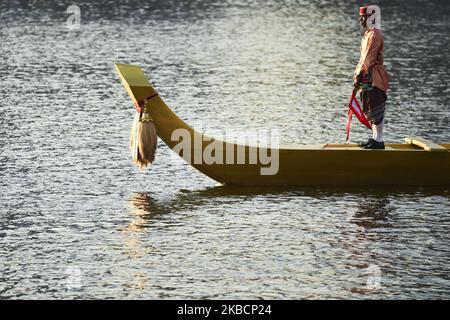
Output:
0,0,450,299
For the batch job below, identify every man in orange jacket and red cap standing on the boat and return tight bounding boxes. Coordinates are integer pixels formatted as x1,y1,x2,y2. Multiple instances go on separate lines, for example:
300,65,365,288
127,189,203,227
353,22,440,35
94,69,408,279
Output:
353,5,389,149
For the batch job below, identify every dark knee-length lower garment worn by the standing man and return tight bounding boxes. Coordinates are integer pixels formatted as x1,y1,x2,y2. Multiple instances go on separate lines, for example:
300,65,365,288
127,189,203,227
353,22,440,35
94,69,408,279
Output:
361,87,387,124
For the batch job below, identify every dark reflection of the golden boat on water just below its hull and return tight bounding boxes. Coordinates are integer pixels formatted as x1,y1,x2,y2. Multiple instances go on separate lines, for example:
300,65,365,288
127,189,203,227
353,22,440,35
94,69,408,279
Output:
126,186,449,225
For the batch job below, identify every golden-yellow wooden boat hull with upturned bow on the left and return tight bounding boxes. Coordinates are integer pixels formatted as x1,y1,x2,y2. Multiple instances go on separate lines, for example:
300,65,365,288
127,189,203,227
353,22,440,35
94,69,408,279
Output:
116,64,450,186
